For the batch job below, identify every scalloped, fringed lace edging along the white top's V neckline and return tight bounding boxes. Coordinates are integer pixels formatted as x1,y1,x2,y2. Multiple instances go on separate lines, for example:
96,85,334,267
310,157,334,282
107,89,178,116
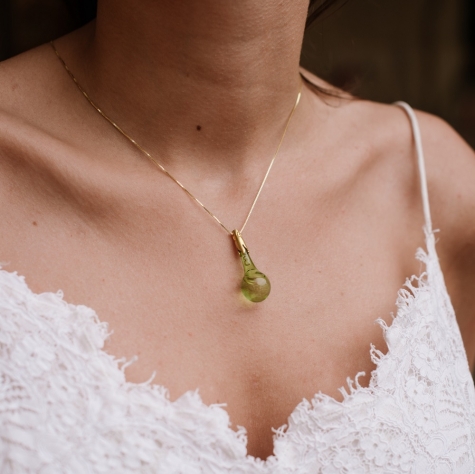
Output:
0,231,443,462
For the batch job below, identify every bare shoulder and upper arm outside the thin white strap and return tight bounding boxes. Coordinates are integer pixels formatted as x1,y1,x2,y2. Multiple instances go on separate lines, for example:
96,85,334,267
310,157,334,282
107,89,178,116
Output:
417,112,475,364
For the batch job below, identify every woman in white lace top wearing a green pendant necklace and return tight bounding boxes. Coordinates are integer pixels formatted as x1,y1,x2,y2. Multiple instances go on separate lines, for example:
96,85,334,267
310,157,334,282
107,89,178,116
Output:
0,0,475,473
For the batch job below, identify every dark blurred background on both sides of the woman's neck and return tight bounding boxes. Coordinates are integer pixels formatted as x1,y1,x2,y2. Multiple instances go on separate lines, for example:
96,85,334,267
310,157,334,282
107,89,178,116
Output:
0,0,475,147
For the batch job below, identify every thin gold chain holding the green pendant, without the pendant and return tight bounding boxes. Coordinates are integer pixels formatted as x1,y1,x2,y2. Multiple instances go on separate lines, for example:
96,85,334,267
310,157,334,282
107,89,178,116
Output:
50,41,303,235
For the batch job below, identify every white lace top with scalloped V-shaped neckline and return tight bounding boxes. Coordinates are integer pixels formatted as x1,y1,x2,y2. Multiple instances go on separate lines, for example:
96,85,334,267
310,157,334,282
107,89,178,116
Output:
0,104,475,474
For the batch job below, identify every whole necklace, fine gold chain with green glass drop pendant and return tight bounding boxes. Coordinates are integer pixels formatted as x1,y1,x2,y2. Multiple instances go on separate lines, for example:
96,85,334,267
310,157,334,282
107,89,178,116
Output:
50,41,302,303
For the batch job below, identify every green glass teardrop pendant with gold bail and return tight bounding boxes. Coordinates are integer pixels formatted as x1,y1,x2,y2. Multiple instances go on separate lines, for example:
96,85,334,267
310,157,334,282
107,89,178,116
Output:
232,229,270,303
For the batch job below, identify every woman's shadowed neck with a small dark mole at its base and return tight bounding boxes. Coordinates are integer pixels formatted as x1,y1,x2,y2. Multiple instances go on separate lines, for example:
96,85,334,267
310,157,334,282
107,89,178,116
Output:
71,0,308,170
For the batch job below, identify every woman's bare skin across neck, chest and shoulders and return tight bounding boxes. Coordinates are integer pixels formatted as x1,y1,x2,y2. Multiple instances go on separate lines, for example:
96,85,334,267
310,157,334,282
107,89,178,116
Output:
0,0,475,458
